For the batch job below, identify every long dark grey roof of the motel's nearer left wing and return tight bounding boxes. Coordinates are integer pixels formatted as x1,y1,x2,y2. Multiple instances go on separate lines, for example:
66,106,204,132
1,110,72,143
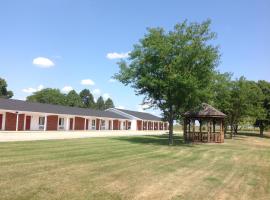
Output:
0,98,128,119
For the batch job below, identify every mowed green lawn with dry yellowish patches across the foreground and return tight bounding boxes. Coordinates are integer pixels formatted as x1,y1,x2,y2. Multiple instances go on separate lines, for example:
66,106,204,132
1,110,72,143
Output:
0,132,270,200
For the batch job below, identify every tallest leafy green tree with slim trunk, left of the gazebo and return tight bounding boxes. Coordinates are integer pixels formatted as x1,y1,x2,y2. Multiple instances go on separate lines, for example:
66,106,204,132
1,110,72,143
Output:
114,20,219,144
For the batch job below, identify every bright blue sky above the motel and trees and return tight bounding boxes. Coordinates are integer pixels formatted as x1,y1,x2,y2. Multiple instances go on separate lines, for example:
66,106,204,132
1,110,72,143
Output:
0,0,270,113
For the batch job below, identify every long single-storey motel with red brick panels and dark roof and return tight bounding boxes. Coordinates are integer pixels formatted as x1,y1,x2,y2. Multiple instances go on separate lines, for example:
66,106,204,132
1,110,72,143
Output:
0,98,168,131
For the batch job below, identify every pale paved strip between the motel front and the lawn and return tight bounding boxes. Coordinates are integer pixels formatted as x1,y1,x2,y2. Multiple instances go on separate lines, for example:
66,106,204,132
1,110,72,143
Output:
0,131,166,142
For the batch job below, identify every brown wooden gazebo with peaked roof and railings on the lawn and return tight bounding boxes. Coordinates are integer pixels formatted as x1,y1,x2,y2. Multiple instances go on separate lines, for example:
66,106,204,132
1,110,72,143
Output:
184,103,226,143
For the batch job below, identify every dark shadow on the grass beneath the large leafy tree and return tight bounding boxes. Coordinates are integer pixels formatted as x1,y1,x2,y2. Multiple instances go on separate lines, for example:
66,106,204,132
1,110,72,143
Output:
113,134,194,147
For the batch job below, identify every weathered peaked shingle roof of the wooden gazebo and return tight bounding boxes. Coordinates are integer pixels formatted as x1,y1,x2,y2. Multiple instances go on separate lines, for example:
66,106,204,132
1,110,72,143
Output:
184,103,226,118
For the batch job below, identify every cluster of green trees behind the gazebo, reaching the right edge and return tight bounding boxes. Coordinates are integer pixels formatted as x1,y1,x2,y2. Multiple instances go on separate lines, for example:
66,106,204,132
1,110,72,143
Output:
209,73,270,136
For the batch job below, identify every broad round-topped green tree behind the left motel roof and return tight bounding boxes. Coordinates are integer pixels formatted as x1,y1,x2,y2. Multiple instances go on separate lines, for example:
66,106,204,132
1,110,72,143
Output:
26,88,65,105
